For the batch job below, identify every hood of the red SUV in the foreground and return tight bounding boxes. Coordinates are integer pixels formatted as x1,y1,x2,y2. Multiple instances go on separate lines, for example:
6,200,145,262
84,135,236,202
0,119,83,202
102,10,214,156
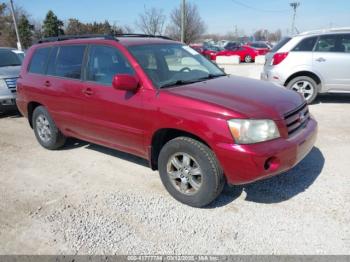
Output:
168,76,304,119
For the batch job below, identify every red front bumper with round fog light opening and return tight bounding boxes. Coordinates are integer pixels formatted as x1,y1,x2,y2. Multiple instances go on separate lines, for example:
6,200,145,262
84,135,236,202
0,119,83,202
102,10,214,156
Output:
215,118,317,185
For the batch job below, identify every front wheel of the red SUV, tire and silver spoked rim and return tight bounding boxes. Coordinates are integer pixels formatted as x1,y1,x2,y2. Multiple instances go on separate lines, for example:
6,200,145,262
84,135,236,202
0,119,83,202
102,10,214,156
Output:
158,137,225,207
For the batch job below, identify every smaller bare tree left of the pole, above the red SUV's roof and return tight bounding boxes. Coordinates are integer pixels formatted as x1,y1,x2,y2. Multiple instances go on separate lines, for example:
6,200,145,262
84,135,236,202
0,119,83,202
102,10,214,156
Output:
135,8,166,35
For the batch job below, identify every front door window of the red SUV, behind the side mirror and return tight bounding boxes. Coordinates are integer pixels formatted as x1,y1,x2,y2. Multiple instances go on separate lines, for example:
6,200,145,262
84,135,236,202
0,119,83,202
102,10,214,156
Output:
86,45,134,85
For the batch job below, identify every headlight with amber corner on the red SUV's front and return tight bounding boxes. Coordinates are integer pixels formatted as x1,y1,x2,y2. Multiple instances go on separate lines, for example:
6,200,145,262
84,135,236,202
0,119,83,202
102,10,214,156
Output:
228,119,280,144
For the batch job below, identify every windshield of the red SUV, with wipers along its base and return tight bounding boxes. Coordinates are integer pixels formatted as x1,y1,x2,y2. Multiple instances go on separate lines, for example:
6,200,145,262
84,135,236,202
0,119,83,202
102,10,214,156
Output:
128,44,225,88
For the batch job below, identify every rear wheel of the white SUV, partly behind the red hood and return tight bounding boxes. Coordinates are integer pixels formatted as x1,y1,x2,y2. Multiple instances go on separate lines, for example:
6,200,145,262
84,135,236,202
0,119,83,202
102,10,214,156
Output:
287,76,319,104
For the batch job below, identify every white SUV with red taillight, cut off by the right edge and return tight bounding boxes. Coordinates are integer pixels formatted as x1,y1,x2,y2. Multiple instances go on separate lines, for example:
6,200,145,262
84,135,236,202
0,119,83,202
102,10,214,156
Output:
261,28,350,103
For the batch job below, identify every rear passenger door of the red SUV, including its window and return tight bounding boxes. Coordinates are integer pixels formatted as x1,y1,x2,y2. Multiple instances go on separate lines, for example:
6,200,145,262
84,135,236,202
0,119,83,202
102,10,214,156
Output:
43,44,87,135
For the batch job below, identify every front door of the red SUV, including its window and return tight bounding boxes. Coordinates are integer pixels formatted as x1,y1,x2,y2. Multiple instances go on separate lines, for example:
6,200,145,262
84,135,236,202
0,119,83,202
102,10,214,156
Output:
81,45,146,155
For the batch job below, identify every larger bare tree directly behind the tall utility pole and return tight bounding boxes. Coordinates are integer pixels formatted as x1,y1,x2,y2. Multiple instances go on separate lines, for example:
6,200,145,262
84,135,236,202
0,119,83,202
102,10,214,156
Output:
166,2,206,44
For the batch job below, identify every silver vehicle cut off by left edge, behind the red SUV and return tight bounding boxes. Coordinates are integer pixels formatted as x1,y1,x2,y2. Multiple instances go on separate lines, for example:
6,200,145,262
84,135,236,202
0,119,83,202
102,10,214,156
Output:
0,47,24,112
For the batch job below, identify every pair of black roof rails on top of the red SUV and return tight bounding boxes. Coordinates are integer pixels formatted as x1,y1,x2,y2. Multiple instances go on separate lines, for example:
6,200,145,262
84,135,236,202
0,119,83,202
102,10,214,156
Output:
37,34,172,44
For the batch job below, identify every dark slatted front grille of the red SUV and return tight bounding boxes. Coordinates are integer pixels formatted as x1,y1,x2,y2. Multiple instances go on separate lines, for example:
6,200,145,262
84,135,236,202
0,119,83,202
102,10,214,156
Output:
284,103,310,136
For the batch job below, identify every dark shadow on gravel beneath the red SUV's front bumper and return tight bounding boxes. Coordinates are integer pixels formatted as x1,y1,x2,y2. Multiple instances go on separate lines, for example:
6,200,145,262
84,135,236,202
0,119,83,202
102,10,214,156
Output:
208,147,325,208
